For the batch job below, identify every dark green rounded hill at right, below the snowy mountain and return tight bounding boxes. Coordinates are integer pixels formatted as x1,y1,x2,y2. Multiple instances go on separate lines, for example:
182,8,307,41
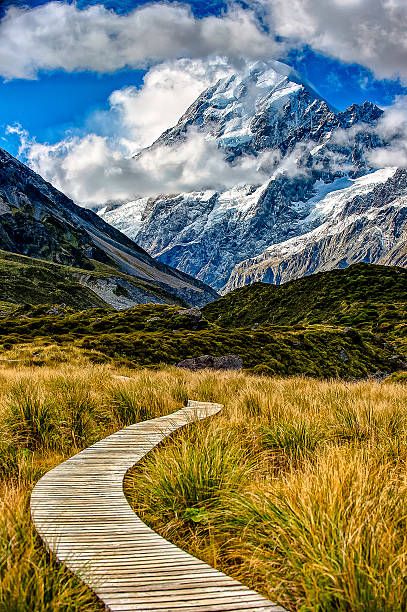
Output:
203,264,407,331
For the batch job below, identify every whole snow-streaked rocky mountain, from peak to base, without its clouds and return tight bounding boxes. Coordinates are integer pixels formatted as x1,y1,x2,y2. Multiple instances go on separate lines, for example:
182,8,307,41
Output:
100,62,407,290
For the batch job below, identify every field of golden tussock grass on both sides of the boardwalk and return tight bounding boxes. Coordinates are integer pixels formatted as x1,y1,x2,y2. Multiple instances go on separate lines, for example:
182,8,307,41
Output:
0,360,407,611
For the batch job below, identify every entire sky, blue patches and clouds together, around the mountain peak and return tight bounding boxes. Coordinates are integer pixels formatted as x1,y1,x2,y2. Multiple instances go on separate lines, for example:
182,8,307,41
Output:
0,0,407,207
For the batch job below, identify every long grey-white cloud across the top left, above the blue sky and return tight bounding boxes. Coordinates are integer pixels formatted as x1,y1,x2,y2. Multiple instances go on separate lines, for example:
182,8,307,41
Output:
0,2,278,79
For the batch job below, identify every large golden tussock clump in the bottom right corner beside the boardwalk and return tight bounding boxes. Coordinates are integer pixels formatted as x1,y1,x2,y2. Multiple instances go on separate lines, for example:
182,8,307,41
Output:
223,447,407,612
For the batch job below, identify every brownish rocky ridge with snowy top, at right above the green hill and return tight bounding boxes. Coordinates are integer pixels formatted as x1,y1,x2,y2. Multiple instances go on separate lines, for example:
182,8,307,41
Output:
225,168,407,291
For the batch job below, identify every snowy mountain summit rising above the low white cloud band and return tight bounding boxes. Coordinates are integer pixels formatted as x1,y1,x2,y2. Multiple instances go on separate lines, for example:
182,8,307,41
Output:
147,60,382,167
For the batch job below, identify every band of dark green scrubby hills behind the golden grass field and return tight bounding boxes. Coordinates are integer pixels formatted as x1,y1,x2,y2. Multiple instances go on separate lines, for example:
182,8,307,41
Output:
0,266,407,378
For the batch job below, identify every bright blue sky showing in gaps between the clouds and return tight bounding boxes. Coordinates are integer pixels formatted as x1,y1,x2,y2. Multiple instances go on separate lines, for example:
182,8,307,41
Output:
0,0,406,154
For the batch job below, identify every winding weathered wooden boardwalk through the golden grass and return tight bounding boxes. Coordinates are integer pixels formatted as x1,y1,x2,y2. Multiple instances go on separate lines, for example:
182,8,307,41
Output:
31,402,284,612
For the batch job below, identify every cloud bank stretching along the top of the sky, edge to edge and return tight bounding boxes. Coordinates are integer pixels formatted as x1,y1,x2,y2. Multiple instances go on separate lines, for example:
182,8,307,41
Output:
0,0,407,82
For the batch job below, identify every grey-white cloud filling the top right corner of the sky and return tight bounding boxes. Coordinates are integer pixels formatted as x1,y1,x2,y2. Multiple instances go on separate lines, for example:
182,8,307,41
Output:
262,0,407,81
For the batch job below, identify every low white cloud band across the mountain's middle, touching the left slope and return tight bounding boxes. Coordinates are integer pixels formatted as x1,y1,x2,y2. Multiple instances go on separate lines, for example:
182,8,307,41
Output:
9,127,274,207
